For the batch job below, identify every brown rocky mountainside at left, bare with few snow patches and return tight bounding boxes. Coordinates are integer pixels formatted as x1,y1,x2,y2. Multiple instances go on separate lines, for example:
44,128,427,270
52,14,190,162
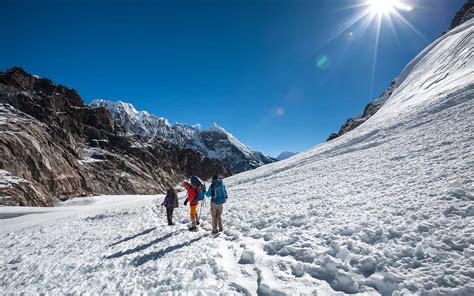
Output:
0,67,229,206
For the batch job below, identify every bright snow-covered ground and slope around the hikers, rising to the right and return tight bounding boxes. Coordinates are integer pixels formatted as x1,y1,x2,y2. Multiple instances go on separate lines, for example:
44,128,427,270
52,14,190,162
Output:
0,17,474,296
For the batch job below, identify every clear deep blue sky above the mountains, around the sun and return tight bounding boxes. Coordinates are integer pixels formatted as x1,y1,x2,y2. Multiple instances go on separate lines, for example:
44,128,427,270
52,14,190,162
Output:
0,0,465,156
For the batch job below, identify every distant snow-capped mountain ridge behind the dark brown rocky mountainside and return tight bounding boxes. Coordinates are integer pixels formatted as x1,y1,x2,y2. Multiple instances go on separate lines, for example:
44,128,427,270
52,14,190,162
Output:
90,100,275,173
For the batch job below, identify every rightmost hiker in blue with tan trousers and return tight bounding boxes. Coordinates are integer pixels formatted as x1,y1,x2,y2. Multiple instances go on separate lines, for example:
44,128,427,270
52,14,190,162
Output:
206,175,227,233
